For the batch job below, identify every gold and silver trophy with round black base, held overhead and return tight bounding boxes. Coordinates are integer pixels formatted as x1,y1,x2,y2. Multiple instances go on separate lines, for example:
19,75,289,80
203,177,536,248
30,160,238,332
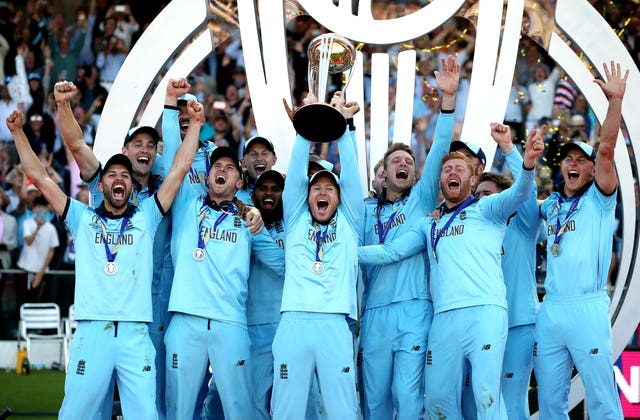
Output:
293,33,356,143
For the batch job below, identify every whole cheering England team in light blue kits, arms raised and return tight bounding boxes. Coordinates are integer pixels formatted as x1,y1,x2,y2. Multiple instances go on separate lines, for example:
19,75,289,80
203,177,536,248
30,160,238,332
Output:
7,57,628,420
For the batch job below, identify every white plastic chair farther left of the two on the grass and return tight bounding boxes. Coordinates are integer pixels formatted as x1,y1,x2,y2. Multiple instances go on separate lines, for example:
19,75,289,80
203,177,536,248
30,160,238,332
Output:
18,303,68,368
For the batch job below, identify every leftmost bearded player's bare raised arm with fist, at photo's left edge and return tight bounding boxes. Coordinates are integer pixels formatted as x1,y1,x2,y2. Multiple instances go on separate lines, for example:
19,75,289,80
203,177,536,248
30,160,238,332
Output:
7,110,67,215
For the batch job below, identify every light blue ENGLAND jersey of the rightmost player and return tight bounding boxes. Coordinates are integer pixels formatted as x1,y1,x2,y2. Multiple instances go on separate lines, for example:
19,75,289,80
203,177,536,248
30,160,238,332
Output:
540,182,618,296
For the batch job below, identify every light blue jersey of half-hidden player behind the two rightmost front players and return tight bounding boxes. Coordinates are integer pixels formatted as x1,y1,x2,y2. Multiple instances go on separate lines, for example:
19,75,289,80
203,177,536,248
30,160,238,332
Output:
502,147,542,328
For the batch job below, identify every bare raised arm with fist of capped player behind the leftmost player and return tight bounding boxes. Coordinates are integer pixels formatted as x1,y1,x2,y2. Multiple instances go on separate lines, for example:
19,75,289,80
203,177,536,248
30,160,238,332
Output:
53,82,100,180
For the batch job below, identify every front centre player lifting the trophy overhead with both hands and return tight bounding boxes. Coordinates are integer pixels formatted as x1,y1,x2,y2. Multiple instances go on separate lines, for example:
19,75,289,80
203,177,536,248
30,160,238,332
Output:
272,92,363,419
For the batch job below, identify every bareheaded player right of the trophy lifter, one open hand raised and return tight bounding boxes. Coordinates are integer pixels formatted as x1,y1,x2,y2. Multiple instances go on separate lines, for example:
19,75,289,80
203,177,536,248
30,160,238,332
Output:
360,56,460,419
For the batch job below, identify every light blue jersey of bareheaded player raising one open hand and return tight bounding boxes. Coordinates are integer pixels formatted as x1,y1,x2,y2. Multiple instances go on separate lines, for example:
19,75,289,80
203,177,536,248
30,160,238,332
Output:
361,113,454,311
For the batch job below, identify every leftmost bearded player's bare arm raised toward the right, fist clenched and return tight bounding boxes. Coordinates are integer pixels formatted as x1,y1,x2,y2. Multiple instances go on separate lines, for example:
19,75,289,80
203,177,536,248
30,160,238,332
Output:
157,100,204,213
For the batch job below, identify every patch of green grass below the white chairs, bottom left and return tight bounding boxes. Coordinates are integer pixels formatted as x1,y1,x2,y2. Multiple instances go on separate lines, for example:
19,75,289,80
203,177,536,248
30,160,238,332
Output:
0,370,64,419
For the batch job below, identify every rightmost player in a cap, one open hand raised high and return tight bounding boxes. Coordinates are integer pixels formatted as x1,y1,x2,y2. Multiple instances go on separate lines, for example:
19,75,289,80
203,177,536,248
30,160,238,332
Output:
534,61,629,419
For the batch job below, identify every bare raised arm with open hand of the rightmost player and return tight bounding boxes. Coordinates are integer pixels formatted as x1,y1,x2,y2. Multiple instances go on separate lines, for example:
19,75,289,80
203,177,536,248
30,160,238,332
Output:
594,60,629,194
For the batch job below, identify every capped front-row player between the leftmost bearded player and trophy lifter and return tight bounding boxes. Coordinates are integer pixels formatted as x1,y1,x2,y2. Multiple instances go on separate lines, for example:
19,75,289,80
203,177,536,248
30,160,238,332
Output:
165,147,284,419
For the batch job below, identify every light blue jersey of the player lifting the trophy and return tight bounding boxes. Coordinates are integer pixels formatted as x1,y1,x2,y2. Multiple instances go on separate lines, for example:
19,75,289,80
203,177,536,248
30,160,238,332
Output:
281,130,364,320
